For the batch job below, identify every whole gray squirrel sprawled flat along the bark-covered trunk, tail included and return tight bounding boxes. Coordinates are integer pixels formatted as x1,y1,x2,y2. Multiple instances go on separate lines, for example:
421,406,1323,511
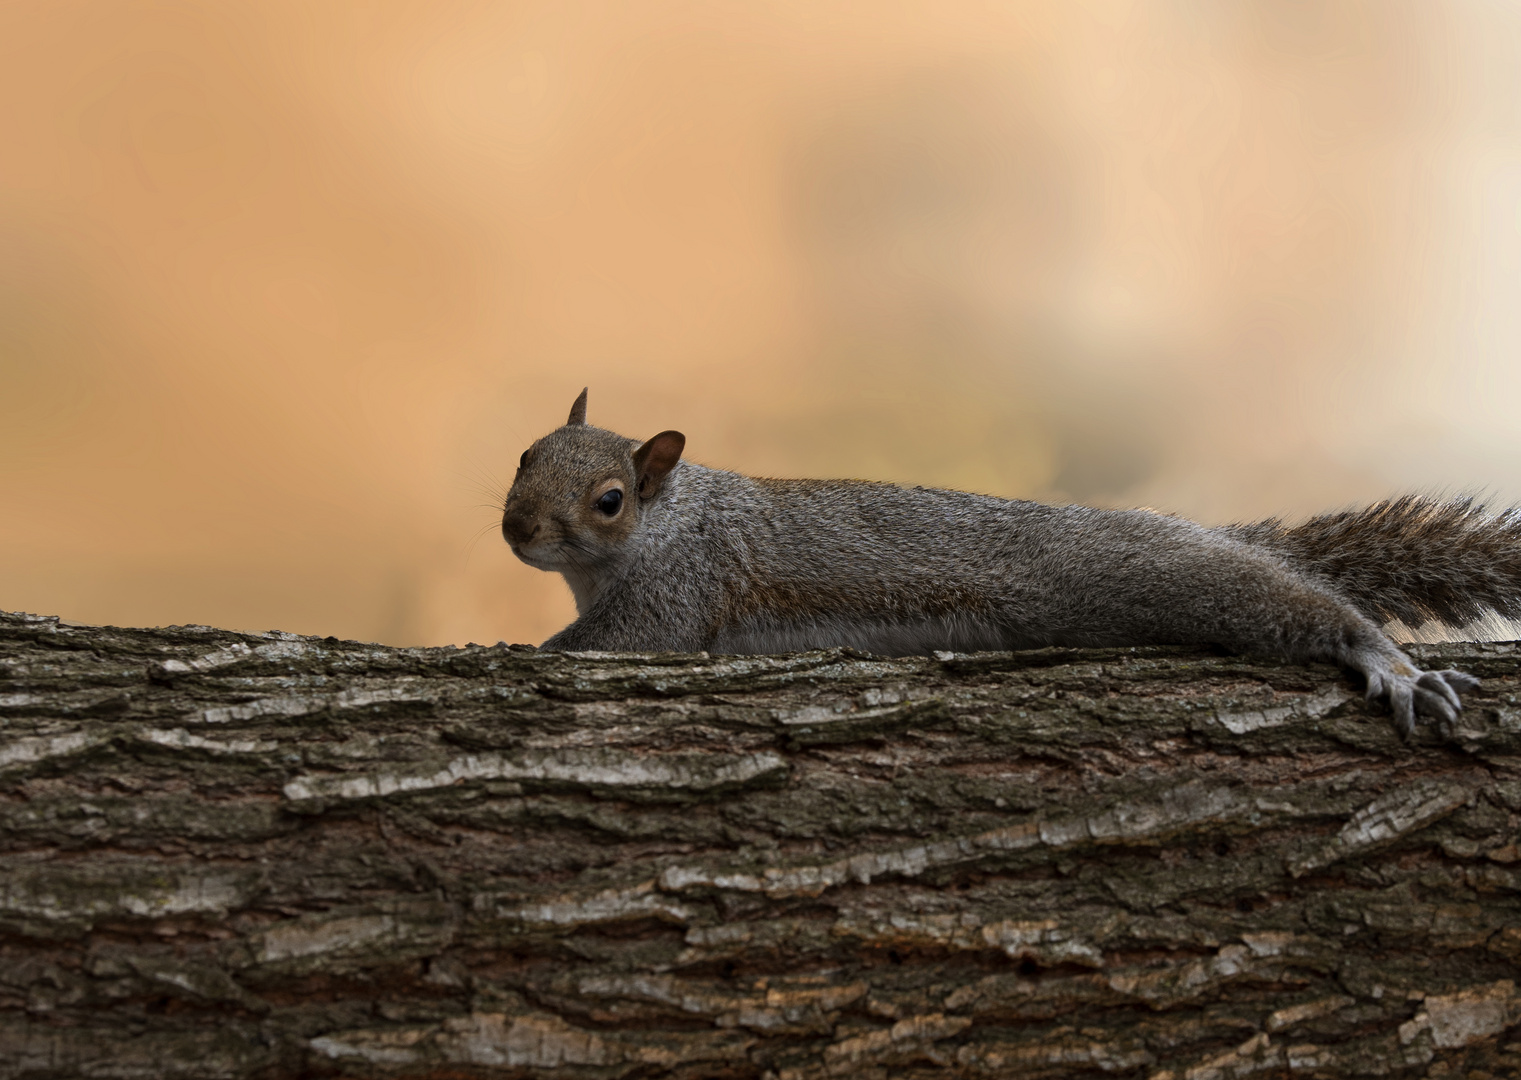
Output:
502,389,1521,736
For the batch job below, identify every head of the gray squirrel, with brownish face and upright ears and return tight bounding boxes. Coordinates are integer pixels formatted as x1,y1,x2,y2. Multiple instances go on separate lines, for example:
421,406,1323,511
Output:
502,389,686,572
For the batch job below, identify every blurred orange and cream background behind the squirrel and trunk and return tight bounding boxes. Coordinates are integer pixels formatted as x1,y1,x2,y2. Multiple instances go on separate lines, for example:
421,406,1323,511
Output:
0,0,1521,645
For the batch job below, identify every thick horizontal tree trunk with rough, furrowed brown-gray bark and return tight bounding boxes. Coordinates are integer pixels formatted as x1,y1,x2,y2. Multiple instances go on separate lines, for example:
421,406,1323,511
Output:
0,616,1521,1080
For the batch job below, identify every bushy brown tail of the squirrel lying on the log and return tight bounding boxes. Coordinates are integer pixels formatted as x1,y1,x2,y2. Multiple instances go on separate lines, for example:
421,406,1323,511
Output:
1220,494,1521,630
